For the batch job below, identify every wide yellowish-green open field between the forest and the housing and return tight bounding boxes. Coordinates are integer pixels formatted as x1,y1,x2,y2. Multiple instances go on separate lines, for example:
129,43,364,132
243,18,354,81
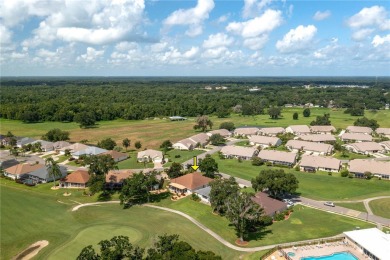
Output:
0,108,390,149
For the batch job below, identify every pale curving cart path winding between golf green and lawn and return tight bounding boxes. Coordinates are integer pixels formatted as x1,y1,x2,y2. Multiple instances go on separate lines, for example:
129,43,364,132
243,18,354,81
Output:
72,201,340,252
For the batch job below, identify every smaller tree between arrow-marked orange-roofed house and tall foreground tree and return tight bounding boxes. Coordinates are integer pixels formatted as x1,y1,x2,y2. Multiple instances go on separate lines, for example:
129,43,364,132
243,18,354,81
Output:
210,177,240,215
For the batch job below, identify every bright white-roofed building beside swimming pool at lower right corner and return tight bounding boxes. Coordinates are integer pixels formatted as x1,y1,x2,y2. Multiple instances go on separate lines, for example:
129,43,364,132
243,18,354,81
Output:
344,228,390,260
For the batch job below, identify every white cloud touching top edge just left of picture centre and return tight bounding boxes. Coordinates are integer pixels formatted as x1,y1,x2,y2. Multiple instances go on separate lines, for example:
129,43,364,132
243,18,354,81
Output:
163,0,214,37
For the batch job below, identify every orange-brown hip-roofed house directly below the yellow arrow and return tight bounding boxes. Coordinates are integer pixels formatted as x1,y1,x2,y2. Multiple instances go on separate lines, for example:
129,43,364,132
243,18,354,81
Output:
169,172,213,194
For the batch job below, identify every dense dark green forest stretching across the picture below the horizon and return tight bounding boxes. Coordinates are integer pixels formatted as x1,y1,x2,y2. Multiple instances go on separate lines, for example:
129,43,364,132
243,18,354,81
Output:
0,78,390,123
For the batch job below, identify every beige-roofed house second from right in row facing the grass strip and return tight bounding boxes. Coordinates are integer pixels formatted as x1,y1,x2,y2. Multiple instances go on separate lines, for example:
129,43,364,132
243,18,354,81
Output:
299,154,341,172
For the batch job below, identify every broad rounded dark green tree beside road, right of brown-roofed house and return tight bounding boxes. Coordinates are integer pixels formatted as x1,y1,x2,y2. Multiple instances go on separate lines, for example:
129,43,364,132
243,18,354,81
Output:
251,169,299,198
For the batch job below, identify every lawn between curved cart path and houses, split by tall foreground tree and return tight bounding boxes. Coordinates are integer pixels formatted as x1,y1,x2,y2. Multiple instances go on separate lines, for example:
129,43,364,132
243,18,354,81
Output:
157,197,373,247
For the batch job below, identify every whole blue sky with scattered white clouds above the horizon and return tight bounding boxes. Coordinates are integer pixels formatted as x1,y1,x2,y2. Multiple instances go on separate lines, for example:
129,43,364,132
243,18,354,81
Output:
0,0,390,76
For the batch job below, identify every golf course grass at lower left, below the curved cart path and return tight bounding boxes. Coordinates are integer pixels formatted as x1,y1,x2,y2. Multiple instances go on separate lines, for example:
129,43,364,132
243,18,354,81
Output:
0,182,250,260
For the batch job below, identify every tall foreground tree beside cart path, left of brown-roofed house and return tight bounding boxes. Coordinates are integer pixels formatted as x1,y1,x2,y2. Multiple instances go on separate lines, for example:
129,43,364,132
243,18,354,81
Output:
226,192,264,242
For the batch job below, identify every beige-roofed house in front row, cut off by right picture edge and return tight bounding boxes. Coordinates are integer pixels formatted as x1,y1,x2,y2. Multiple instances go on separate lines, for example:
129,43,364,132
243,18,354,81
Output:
348,159,390,180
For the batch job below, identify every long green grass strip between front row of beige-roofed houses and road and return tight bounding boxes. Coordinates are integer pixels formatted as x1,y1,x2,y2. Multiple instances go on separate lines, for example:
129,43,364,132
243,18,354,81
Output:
213,155,390,200
